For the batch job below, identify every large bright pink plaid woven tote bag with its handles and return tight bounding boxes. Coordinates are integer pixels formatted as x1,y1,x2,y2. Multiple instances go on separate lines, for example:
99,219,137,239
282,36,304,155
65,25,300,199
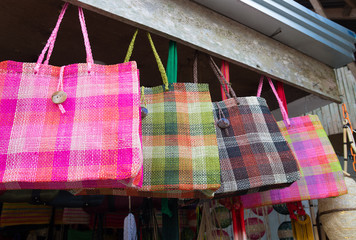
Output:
0,4,142,189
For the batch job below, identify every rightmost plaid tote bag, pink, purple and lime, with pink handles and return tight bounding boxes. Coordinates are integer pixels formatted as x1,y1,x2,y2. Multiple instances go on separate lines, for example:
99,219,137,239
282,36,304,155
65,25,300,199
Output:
241,77,347,208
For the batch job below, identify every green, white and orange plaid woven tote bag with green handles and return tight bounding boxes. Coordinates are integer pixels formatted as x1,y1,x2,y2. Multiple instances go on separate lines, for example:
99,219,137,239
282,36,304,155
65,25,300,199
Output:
72,31,220,198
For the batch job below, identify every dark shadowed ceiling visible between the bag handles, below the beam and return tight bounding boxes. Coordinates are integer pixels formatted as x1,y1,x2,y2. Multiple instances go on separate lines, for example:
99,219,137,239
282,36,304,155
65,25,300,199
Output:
0,0,336,109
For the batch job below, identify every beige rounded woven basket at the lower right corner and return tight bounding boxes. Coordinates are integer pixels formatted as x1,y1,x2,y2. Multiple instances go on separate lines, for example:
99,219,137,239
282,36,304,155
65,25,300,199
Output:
319,177,356,240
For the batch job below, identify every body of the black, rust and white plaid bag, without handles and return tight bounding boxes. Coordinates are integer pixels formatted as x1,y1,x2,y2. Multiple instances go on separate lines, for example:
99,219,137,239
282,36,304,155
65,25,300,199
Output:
214,97,300,197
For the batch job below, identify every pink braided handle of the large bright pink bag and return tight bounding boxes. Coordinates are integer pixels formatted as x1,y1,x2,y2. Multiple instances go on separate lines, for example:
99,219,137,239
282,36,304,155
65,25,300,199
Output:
35,3,94,73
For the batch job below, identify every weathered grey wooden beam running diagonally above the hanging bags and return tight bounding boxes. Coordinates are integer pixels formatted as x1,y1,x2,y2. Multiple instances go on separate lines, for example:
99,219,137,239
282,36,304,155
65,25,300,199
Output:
66,0,340,102
